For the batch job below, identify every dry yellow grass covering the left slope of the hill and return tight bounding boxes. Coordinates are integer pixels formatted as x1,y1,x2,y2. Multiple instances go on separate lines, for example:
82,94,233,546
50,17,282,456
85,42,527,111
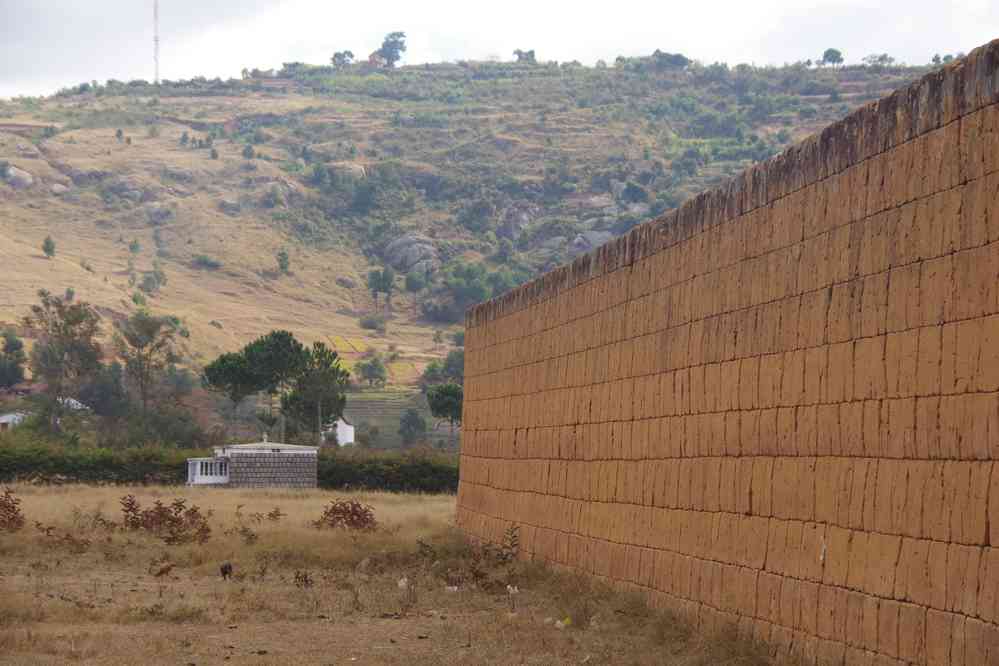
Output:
0,96,450,374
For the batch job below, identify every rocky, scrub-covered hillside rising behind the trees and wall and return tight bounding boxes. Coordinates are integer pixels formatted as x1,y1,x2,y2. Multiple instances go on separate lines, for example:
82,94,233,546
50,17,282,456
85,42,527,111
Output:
0,57,925,385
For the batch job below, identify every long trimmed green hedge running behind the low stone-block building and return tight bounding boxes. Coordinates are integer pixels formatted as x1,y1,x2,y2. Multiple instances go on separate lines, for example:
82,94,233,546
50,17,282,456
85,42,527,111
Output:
0,444,458,493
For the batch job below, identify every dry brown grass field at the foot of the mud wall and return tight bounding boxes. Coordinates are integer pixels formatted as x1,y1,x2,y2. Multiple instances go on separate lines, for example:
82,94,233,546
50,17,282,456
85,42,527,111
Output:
0,485,769,666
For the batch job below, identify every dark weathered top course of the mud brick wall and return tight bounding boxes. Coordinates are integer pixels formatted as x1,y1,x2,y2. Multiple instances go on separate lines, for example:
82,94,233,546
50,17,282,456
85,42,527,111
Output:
465,39,999,329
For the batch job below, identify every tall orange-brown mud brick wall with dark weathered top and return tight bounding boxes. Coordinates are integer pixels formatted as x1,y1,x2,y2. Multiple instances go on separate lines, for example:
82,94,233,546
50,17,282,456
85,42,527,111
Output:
458,41,999,666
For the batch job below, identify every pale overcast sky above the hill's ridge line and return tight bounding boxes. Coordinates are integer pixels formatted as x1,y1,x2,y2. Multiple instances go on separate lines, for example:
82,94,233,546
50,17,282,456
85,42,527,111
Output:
0,0,999,97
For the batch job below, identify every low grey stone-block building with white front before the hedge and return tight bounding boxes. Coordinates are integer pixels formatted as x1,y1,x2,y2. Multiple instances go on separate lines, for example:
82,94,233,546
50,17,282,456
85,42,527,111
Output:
187,436,319,488
